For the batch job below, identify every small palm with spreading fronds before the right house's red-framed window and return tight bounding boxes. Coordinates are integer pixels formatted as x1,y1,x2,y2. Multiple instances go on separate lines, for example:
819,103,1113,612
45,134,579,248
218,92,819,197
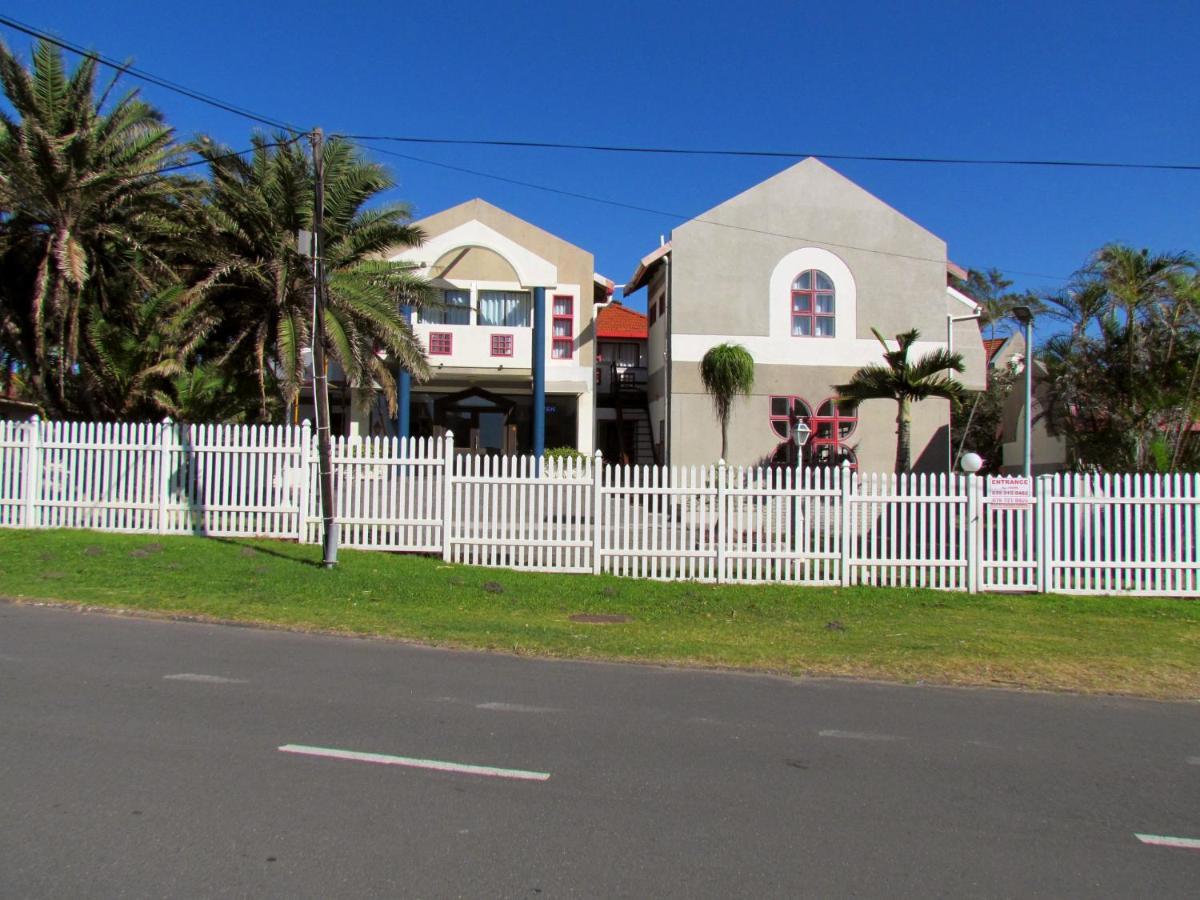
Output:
838,328,962,475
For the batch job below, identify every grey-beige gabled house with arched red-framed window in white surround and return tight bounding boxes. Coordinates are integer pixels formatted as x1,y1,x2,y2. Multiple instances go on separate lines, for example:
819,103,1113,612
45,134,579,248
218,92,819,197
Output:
624,158,985,472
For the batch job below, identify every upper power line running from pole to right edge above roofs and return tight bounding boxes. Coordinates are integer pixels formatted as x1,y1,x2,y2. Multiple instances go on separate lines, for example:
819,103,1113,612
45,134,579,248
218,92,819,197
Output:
342,134,1200,172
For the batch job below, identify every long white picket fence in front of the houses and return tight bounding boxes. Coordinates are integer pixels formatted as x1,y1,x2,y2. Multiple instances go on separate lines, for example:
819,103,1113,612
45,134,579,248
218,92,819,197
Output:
0,420,1200,596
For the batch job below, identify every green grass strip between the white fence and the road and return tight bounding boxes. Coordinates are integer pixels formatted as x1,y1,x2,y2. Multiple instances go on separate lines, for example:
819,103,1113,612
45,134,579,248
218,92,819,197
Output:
0,530,1200,700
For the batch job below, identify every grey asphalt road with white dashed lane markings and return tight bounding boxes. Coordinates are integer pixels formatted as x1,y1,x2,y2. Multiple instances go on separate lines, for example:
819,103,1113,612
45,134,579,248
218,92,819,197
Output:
0,604,1200,898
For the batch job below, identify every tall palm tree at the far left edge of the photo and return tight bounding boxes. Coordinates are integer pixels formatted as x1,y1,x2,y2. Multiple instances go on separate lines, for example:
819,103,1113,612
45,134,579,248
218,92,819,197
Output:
0,42,190,412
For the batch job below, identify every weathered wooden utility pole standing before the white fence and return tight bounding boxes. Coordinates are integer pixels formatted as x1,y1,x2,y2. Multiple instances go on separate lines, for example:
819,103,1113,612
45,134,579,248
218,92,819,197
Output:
312,128,337,569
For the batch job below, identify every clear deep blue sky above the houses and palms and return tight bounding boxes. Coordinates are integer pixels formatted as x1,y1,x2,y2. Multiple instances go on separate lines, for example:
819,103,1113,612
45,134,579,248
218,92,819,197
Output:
0,0,1200,314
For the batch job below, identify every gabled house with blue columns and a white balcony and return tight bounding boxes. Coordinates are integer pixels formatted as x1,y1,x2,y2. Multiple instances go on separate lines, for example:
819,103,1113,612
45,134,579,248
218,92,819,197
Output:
358,199,600,454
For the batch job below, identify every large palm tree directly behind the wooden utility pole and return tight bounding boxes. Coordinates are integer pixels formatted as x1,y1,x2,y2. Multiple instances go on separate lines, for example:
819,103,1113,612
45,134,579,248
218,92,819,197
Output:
193,134,439,419
